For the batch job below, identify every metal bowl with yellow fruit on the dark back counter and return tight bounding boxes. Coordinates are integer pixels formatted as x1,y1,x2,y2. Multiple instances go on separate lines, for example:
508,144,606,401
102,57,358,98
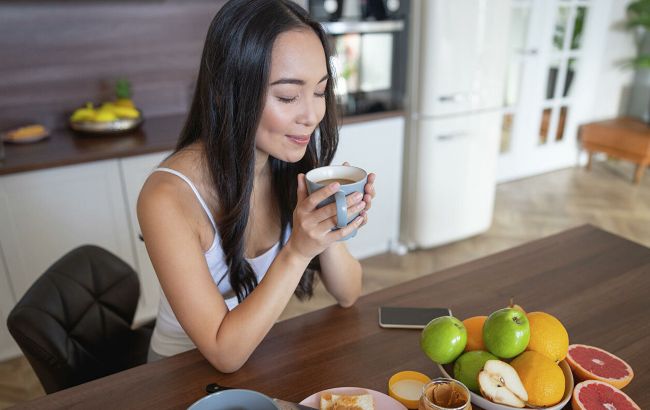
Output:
69,80,143,134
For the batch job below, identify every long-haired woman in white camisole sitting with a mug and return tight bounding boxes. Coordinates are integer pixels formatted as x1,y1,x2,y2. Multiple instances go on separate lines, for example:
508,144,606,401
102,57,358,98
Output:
138,0,375,372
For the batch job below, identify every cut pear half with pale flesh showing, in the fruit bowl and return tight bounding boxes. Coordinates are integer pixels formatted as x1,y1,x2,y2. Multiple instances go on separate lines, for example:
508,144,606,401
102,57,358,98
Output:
478,360,528,408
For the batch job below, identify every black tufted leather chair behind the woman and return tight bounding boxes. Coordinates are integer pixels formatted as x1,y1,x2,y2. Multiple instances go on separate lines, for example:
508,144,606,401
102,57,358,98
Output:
7,245,153,393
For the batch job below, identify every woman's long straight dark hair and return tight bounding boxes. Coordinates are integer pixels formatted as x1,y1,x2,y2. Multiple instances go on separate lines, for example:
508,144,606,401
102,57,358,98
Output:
175,0,338,302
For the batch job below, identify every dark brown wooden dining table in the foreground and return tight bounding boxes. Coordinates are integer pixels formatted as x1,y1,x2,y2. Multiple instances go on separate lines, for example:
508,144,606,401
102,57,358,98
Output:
18,225,650,410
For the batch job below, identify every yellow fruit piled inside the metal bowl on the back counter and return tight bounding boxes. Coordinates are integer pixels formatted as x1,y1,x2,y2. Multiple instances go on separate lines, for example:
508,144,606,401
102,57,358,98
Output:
70,80,140,123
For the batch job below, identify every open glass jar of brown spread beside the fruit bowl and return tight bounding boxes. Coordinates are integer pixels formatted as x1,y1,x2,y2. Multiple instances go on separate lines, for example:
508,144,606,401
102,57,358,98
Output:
418,378,472,410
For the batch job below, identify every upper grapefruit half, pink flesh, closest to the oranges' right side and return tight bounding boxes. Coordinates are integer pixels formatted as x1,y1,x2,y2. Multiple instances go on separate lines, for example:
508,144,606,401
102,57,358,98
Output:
566,344,634,389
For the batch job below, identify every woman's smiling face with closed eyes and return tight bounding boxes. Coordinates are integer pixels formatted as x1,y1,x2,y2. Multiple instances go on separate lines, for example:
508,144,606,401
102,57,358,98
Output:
255,30,328,162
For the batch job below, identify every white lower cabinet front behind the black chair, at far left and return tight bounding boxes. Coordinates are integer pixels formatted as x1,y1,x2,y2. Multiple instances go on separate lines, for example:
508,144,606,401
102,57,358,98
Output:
0,160,134,358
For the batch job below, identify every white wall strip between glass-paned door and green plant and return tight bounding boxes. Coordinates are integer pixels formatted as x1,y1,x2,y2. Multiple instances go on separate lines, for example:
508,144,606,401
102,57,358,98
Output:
590,0,636,120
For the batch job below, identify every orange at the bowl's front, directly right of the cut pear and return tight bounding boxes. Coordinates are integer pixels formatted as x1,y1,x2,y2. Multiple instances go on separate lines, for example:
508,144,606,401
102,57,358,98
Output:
510,351,564,406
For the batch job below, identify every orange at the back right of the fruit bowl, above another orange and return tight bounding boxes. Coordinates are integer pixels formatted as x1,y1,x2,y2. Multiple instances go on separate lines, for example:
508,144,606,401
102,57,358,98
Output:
526,312,569,363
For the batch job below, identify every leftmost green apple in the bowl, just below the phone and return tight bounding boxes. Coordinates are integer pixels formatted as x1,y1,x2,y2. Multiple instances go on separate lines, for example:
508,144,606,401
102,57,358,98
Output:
420,316,467,364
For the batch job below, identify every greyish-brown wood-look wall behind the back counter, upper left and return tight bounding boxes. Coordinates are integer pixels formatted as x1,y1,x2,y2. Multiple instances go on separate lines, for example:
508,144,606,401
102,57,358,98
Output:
0,0,225,130
